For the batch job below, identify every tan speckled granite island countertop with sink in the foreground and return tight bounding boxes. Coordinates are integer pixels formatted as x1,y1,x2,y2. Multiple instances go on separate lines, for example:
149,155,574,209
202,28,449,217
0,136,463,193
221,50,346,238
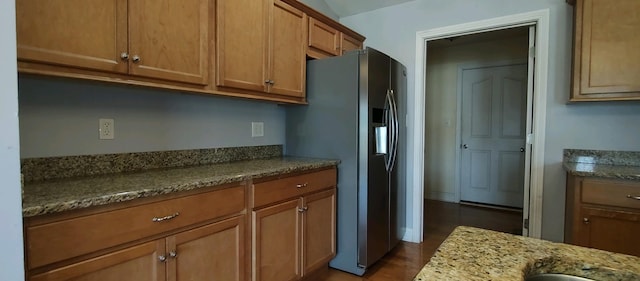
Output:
414,226,640,281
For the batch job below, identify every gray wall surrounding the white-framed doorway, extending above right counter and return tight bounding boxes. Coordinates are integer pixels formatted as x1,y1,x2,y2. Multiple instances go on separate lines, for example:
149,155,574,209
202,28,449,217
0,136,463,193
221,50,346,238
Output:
340,0,640,241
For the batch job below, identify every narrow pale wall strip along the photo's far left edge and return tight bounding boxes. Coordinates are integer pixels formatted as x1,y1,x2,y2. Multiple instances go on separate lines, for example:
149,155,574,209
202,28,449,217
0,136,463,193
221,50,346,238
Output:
0,1,24,281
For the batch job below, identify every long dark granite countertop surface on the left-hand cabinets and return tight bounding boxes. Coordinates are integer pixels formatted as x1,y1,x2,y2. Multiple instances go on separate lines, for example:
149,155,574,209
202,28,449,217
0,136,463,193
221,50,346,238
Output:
22,157,339,217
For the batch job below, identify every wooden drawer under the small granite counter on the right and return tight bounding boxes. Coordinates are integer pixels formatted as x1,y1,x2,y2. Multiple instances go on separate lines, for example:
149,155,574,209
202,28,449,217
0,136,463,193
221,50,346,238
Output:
582,179,640,209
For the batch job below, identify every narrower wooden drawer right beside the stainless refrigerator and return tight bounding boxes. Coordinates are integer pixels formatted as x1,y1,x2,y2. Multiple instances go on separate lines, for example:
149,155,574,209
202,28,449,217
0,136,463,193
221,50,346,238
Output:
252,168,336,207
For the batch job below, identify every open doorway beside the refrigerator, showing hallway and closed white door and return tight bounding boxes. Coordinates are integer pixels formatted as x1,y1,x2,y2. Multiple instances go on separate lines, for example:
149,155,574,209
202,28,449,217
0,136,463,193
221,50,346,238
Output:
424,26,529,233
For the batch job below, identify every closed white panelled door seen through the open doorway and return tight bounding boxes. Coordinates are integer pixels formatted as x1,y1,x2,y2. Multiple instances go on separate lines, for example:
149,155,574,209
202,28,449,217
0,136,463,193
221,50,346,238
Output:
460,63,527,208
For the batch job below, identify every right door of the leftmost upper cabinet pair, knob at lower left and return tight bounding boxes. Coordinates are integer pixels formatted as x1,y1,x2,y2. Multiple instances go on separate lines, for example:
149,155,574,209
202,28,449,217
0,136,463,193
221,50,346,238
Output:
129,0,211,85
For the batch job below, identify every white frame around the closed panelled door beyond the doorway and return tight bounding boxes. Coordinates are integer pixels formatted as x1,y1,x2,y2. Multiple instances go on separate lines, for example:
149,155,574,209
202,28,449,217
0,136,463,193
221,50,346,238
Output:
454,59,533,206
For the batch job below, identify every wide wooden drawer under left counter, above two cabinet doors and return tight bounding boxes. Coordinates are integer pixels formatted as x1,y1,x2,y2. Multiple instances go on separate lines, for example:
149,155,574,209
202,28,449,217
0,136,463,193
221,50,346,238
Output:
26,186,245,269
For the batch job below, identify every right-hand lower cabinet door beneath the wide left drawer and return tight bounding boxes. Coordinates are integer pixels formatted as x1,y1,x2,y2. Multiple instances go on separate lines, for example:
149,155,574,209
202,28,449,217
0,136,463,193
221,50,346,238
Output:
167,216,246,281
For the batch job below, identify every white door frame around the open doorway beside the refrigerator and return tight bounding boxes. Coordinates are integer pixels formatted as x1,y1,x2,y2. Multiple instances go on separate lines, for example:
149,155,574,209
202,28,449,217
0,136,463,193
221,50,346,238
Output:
410,9,549,243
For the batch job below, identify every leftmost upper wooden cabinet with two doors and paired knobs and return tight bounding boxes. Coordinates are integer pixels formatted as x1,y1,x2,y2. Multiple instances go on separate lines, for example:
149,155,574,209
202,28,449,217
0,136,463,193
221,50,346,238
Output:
16,0,211,85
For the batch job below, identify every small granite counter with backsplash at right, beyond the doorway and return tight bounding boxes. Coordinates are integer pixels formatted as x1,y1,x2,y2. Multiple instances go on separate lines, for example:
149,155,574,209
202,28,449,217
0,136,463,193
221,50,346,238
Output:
562,149,640,180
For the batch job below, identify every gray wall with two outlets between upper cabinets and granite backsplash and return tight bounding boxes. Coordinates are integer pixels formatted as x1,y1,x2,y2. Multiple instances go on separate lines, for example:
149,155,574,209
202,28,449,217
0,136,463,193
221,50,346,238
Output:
18,75,284,158
